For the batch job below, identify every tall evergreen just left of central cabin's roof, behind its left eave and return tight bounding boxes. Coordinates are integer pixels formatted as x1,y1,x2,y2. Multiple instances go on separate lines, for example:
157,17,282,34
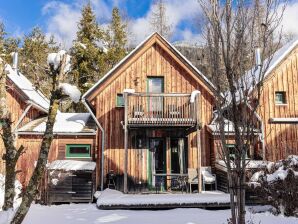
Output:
71,2,105,96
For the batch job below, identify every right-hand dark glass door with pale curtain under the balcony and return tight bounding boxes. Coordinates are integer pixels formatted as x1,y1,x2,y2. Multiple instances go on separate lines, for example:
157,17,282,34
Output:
171,138,188,174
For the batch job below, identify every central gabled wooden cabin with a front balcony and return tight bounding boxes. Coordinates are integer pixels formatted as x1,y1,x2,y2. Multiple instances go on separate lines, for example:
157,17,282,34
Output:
83,33,214,192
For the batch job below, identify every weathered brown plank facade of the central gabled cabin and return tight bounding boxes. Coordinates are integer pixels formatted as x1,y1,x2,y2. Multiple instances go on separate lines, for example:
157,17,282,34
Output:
85,34,214,190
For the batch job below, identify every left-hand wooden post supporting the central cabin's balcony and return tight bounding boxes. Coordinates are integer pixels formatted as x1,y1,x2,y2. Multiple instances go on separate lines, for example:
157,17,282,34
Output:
123,92,128,194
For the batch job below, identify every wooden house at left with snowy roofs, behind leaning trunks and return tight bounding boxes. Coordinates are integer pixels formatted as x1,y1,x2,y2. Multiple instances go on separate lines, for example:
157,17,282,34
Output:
0,60,96,195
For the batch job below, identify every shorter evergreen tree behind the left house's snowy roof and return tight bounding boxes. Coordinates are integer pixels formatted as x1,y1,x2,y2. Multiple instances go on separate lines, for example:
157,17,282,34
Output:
19,27,58,95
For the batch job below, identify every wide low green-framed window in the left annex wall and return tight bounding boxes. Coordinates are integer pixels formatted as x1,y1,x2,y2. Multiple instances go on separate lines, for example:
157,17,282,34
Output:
66,144,91,158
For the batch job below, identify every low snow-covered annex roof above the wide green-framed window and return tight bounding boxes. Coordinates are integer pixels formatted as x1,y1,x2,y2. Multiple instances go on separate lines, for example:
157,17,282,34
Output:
18,112,96,135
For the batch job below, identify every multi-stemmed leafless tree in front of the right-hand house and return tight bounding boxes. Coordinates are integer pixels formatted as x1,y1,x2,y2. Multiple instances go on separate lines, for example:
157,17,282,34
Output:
199,0,283,224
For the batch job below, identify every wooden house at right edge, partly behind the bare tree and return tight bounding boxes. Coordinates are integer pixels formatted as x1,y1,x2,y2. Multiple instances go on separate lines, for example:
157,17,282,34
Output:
208,40,298,172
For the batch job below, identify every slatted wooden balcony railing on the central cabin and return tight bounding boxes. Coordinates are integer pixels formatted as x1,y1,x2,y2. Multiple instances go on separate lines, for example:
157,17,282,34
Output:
124,93,197,126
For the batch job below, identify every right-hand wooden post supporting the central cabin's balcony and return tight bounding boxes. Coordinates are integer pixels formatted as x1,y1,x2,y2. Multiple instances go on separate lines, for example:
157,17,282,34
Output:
195,94,202,193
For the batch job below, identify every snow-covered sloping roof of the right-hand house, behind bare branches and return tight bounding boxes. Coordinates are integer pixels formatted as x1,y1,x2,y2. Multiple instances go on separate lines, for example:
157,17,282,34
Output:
234,39,298,101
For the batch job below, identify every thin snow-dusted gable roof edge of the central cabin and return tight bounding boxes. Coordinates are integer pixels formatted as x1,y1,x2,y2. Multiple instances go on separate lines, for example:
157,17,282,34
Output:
82,32,215,99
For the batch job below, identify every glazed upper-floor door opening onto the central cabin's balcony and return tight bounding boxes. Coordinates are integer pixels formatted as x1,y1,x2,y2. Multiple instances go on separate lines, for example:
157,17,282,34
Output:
147,77,164,118
